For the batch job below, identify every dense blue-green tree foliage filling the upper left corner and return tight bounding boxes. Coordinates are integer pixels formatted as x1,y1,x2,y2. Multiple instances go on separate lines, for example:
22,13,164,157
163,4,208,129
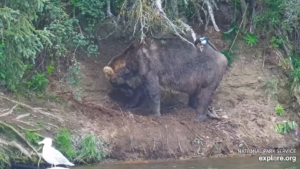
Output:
0,0,94,91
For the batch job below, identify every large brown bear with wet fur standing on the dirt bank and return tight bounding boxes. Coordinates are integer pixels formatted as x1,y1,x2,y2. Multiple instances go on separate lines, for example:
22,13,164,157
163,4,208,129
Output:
103,34,228,121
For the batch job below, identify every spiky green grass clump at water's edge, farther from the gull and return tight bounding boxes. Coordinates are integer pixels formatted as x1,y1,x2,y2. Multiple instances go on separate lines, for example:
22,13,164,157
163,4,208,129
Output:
76,135,105,163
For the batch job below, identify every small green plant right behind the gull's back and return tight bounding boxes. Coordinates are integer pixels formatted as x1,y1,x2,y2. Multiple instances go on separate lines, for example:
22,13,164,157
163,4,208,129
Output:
55,128,76,159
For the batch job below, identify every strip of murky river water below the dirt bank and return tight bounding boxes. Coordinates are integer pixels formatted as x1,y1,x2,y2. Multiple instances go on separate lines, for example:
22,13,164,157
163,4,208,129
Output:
72,154,300,169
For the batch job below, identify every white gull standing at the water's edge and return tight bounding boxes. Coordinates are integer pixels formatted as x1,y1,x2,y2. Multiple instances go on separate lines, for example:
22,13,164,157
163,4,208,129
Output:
38,138,74,167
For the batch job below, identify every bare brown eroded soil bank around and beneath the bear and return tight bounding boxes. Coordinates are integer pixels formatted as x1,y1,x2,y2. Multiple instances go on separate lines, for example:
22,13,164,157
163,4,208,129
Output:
1,26,300,165
